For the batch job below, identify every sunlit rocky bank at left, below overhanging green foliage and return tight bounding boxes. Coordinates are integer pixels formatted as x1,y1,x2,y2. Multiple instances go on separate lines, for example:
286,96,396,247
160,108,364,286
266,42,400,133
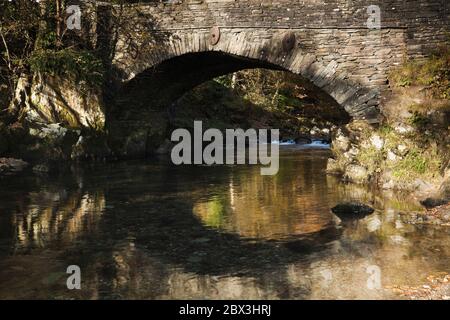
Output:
0,75,112,165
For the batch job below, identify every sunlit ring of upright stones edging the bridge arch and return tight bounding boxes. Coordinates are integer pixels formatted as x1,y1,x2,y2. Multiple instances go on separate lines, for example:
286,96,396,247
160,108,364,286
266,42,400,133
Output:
116,28,381,122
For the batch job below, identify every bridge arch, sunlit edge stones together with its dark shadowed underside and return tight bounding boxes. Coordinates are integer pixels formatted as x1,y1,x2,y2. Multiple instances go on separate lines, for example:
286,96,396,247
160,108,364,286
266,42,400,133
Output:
106,29,380,156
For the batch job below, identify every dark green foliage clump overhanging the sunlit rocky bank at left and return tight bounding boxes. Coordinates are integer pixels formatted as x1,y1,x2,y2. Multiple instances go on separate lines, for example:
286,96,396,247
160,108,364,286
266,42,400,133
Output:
29,48,104,87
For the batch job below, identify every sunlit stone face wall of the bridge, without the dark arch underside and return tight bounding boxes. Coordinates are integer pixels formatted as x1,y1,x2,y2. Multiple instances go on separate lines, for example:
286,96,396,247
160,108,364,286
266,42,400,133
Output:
92,0,449,122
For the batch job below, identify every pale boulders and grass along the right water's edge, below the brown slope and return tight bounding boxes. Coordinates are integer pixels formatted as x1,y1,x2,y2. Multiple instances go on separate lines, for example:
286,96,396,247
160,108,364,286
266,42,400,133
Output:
327,116,450,196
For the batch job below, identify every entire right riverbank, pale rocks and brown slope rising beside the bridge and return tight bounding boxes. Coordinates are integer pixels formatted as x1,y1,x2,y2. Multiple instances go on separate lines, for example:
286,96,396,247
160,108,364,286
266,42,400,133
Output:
327,49,450,204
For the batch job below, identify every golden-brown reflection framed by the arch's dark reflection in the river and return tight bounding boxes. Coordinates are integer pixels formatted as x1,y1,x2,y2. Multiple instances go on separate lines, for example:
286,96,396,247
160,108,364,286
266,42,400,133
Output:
193,155,333,240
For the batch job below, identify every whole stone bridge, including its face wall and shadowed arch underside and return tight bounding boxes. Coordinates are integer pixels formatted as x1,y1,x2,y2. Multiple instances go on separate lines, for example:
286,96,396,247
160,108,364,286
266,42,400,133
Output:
80,0,450,155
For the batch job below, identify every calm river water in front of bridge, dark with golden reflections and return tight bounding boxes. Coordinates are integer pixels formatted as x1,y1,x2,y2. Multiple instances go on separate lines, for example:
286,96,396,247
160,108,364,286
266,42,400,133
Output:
0,146,450,299
